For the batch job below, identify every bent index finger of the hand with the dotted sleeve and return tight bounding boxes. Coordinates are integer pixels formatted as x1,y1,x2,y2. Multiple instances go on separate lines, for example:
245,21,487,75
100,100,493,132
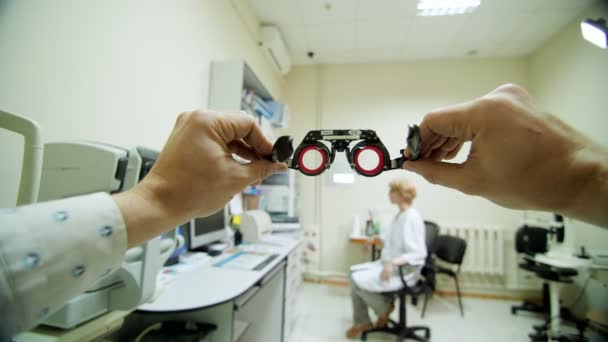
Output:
224,112,272,156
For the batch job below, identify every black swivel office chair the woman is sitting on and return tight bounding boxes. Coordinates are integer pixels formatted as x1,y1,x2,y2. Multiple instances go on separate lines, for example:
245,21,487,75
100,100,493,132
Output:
361,266,431,342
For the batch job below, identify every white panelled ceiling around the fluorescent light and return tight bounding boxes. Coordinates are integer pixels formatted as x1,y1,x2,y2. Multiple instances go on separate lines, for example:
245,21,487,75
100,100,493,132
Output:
249,0,594,64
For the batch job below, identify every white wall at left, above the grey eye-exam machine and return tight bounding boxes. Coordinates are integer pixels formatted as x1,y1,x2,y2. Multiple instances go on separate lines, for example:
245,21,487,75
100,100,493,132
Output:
0,0,283,207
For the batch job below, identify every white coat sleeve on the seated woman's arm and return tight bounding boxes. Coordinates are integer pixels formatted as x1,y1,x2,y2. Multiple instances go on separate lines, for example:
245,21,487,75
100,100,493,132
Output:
398,213,427,266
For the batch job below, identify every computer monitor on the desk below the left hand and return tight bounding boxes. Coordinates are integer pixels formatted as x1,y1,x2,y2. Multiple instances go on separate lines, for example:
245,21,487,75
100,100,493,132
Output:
188,207,228,250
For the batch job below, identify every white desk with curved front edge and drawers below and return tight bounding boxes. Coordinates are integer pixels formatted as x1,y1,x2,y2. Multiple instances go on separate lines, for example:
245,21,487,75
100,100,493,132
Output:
114,234,301,342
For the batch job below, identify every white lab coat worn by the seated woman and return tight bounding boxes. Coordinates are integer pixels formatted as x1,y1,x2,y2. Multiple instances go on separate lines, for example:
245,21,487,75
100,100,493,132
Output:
351,207,427,292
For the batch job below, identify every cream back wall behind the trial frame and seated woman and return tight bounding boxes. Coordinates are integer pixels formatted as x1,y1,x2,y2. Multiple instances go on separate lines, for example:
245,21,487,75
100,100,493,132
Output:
285,58,528,274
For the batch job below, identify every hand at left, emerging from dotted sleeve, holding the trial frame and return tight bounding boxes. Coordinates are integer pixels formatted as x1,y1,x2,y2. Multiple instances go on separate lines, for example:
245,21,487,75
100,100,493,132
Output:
115,111,287,246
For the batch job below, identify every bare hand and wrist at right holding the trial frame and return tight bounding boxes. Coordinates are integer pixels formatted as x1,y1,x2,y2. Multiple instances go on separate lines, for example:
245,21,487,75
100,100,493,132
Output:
404,85,608,225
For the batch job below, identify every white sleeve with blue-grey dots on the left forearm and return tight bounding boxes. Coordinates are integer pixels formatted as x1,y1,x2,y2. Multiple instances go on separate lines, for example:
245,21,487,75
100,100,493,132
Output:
0,193,127,341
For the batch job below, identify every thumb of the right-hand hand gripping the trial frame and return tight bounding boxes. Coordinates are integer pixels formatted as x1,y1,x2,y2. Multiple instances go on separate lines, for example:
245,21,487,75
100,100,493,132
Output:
403,159,474,194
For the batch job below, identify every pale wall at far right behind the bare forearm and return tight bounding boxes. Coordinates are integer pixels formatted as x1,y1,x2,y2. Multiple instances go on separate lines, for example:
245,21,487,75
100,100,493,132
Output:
529,2,608,316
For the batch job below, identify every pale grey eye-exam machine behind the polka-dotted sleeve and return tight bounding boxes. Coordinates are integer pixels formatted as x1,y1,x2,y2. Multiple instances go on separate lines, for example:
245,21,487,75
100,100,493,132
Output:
39,142,183,329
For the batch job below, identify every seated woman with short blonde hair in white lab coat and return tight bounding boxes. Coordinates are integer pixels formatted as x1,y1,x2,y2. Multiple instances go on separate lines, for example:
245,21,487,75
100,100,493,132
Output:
346,180,427,338
